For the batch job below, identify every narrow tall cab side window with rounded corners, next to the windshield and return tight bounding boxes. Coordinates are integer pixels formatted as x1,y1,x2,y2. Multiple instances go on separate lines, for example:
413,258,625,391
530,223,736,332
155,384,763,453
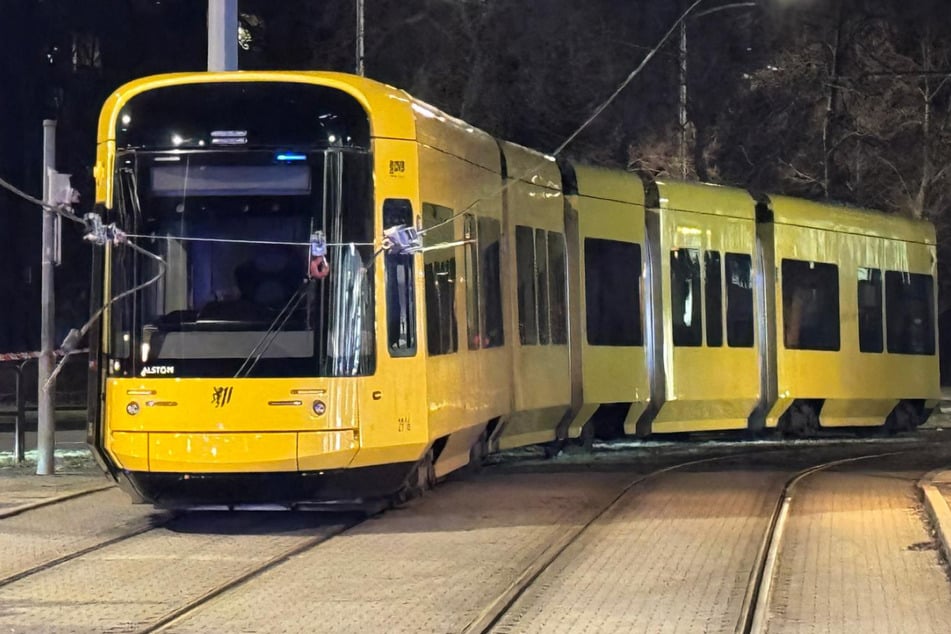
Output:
383,198,416,357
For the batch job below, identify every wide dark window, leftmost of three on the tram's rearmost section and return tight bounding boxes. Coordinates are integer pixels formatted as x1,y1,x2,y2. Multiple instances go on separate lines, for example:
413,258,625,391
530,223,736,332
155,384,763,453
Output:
782,259,839,350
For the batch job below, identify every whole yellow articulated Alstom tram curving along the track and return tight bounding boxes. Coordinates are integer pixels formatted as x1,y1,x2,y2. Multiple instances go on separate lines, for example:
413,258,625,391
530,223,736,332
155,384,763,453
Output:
89,72,938,506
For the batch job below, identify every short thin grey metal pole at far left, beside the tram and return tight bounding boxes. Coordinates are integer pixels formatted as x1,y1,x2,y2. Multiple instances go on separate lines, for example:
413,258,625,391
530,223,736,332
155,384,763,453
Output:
36,119,56,475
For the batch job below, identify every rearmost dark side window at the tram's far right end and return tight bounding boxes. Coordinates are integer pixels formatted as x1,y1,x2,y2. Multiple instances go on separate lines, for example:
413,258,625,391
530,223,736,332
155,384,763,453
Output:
885,271,935,355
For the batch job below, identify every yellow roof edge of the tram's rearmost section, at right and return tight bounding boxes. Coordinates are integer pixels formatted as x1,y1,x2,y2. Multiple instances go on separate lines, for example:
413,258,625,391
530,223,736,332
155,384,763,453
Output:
764,195,936,244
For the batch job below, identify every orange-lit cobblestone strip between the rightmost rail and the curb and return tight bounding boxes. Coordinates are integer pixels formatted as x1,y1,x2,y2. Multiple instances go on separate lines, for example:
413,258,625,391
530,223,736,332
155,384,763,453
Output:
768,460,951,634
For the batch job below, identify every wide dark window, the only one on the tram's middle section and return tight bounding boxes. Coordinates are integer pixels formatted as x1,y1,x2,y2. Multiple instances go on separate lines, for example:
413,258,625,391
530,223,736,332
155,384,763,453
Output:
584,238,644,346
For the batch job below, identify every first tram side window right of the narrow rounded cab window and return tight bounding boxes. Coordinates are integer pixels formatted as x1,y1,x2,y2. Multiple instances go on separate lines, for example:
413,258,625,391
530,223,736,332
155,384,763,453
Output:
423,203,459,355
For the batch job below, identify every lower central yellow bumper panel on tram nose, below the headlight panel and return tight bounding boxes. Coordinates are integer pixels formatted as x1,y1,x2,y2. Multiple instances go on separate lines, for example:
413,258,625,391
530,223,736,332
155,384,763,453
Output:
149,433,297,473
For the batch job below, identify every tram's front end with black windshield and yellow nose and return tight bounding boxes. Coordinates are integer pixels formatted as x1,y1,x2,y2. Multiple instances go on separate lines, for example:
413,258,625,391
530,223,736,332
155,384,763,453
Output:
89,76,412,506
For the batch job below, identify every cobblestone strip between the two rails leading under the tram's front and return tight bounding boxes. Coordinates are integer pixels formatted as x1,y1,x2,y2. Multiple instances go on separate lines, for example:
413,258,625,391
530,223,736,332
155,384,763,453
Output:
0,512,356,634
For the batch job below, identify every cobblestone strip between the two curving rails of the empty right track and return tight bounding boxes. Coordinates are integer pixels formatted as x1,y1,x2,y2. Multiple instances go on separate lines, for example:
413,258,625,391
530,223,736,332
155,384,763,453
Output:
493,470,786,633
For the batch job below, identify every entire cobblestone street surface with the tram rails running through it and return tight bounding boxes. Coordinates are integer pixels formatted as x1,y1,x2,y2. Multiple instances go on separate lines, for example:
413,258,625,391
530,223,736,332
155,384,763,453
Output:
0,436,951,634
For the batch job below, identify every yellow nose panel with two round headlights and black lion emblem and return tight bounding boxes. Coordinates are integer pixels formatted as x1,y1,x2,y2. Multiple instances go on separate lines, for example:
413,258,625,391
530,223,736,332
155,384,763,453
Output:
106,379,359,433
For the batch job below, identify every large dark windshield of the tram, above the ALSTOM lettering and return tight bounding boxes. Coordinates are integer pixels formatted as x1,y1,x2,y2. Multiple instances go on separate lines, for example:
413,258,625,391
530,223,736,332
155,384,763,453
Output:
107,148,374,377
